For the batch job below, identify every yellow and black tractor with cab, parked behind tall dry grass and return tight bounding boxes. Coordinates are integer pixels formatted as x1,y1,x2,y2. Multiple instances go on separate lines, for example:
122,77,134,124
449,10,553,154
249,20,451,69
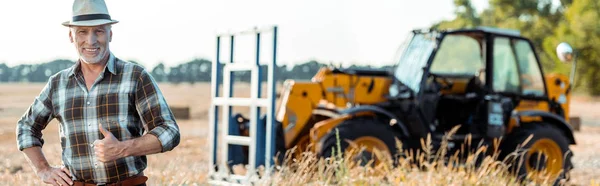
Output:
232,28,575,182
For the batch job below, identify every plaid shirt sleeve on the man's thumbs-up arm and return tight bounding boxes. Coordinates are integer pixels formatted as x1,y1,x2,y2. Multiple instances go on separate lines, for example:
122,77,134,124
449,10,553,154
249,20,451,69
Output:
135,70,180,152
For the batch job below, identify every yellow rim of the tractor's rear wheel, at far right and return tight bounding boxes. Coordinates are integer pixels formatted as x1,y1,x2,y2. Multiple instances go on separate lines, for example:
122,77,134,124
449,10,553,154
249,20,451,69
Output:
523,138,563,179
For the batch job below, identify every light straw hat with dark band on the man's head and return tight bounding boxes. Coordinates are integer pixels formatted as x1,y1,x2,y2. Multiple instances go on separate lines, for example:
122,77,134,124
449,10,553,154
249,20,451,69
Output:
62,0,119,26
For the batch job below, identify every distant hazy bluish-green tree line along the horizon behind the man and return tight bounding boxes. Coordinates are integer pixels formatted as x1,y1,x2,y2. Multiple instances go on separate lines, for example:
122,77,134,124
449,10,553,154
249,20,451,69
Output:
0,59,392,83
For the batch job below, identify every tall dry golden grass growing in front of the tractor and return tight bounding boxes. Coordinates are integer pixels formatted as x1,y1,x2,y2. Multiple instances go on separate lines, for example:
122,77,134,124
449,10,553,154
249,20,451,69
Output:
226,128,597,185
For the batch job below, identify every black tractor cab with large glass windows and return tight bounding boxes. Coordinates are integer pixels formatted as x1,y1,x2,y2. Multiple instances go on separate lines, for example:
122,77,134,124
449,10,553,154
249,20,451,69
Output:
389,28,560,141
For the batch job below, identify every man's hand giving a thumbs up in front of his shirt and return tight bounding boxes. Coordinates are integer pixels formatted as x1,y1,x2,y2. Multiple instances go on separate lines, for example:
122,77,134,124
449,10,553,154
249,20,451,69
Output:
94,124,126,162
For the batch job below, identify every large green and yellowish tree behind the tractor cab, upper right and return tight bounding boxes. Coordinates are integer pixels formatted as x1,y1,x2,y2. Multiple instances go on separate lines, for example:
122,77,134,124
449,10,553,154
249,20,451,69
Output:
432,0,600,95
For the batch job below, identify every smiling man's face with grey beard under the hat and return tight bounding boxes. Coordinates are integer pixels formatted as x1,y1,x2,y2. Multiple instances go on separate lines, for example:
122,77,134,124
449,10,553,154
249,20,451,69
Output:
69,25,112,64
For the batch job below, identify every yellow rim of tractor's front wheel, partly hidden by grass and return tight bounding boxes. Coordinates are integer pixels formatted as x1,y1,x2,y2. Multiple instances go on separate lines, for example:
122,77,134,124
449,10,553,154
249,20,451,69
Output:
346,136,390,166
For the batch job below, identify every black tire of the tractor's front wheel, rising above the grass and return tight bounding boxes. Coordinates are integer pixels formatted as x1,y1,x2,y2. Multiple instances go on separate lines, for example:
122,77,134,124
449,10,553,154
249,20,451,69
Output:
319,117,402,165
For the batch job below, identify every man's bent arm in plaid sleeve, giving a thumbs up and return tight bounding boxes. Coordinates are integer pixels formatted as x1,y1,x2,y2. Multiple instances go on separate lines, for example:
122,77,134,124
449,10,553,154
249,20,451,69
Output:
94,70,180,162
